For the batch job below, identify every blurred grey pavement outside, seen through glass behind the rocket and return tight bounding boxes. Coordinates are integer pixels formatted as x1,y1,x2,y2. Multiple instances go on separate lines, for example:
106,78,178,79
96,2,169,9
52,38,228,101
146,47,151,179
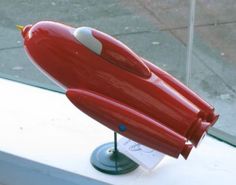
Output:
0,0,236,146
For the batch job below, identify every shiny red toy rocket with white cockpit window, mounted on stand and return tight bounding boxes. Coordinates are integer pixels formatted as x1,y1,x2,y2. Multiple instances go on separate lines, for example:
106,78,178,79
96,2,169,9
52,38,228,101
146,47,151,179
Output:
17,21,218,159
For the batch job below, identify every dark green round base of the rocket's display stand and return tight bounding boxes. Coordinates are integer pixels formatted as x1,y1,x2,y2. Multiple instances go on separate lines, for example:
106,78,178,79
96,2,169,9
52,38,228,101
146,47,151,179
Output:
90,143,138,175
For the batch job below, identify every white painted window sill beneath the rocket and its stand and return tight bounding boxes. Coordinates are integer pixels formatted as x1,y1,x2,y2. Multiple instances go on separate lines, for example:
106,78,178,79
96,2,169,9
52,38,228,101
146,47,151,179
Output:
0,79,236,185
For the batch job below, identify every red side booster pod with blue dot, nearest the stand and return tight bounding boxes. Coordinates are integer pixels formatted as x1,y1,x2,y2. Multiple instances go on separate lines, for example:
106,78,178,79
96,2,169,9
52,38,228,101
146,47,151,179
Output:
66,89,191,158
